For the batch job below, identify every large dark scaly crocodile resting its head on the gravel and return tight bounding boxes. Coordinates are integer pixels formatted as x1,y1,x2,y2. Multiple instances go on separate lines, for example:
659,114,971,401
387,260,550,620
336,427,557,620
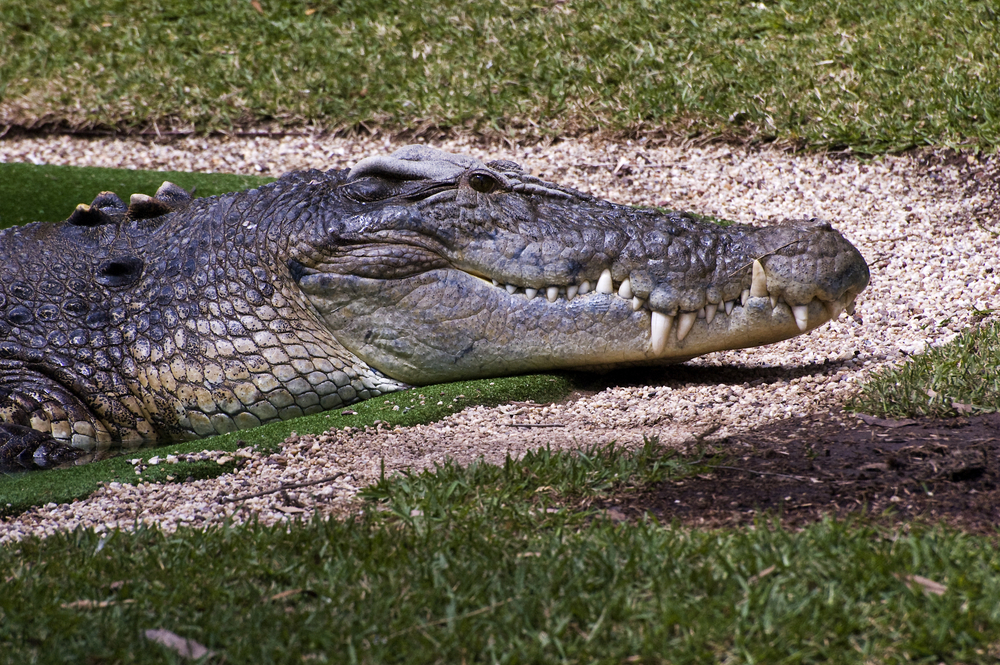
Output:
0,146,869,467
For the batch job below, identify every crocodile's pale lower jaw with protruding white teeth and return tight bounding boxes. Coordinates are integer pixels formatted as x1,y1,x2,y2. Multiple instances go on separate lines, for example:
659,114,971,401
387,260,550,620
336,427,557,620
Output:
300,262,853,385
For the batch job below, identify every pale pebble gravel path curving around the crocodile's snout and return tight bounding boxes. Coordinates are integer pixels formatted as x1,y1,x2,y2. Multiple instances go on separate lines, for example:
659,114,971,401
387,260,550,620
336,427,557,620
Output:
0,137,1000,543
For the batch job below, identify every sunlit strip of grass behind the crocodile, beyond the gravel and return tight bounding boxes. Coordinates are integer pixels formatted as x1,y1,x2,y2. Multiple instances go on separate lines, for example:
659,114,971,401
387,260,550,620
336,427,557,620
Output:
0,0,1000,151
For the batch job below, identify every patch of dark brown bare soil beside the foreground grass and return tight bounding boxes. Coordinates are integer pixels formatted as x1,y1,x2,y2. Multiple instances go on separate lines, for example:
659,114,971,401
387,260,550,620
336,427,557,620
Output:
606,412,1000,535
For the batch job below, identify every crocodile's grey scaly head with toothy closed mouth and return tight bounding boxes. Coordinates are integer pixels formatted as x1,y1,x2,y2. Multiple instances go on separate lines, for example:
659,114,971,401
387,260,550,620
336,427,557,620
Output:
292,146,869,384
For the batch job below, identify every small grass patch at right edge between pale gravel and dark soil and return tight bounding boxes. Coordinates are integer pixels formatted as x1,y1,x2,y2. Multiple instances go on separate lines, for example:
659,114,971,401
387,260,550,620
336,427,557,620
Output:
848,321,1000,418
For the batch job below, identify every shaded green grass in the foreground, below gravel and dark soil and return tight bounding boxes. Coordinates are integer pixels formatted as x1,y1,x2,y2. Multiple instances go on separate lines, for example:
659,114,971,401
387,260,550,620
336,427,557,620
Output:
0,441,1000,663
